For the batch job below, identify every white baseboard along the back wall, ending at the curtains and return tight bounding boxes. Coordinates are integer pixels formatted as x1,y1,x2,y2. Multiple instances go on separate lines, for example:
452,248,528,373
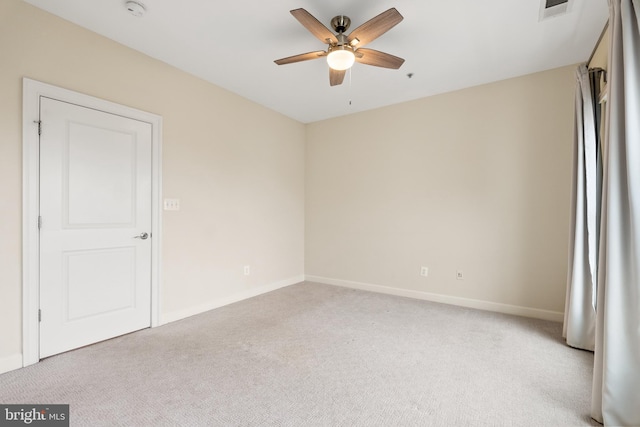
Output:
305,275,564,322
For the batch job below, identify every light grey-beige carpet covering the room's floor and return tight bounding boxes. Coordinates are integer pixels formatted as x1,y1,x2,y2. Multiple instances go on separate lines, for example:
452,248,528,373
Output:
0,283,598,426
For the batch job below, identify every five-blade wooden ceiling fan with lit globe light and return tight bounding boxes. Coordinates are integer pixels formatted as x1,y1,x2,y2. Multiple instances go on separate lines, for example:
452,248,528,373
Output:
274,7,404,86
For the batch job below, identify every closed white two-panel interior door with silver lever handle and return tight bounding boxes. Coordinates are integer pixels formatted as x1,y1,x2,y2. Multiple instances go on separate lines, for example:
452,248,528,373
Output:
40,97,152,357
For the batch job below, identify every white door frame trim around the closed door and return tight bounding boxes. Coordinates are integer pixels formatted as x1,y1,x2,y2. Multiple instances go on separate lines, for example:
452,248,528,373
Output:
22,77,162,366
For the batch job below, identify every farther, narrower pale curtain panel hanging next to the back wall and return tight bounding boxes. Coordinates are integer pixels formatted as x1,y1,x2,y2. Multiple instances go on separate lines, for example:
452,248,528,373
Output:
563,64,601,350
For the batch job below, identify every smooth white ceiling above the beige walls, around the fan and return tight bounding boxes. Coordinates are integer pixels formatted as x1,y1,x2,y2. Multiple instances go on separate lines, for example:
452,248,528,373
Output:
25,0,608,123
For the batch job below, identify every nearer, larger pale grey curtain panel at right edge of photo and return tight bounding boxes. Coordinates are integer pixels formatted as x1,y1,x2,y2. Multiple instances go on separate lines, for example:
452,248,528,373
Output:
591,0,640,426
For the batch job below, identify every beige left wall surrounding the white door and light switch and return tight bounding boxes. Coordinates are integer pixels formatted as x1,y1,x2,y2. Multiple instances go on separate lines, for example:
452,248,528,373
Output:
0,0,305,372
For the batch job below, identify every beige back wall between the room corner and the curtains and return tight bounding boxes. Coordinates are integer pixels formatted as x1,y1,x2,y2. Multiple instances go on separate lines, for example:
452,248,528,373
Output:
305,66,576,317
